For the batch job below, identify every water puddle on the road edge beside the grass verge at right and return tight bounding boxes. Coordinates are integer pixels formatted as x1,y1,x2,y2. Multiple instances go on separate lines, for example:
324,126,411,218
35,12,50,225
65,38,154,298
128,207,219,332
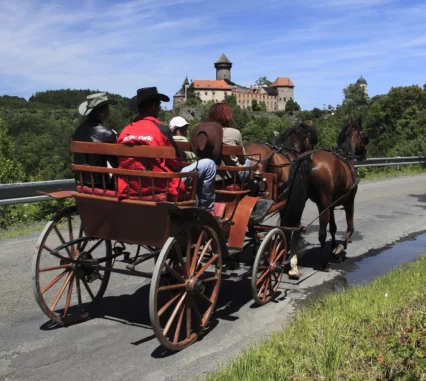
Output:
337,233,426,291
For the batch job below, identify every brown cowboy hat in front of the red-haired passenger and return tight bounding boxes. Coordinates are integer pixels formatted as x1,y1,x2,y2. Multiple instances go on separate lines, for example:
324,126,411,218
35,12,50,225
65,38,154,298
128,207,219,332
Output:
190,122,223,161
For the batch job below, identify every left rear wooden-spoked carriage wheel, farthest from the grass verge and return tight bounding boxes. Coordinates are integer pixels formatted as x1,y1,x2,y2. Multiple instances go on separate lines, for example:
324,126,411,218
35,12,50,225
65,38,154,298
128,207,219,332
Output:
32,206,112,324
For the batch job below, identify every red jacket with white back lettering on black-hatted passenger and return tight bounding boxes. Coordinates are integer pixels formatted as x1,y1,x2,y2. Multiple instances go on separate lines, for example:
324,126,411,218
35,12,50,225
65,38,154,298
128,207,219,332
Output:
117,116,185,197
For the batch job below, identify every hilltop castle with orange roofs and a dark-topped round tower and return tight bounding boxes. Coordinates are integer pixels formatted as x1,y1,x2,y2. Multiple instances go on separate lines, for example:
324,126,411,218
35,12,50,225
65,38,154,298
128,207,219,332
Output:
173,54,294,112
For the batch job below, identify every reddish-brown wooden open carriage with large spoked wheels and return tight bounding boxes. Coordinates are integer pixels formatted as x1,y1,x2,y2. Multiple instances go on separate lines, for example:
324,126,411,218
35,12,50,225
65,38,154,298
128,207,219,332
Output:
33,120,368,350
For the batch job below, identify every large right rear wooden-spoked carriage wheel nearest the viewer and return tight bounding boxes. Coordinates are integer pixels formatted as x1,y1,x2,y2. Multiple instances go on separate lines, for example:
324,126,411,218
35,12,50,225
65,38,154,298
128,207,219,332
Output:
149,222,222,351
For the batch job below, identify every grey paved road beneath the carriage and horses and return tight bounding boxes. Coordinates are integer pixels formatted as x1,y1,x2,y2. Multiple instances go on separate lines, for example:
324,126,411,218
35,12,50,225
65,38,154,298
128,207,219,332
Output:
0,175,426,381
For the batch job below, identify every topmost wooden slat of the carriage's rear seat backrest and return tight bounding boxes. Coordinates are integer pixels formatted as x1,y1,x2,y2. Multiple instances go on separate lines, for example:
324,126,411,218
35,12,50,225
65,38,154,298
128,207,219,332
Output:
71,142,176,159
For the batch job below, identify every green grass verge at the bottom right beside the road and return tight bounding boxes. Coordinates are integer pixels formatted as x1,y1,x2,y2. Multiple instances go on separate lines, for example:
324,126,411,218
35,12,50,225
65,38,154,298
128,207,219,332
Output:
205,253,426,381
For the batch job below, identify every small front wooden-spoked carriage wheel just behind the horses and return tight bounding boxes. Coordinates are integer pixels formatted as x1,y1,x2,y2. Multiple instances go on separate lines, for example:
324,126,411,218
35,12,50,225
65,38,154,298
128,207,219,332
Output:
251,228,287,305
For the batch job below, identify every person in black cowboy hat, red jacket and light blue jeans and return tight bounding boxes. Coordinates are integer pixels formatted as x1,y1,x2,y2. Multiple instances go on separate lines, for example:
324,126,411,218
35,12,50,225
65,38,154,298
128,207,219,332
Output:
117,87,216,211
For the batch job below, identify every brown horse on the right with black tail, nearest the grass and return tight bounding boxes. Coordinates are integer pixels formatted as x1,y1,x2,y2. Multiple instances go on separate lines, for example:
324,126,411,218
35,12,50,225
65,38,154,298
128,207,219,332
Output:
281,122,368,278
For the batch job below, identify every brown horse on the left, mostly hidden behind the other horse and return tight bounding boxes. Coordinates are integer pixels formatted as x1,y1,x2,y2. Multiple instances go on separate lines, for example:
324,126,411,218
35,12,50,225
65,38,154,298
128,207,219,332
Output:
245,123,318,201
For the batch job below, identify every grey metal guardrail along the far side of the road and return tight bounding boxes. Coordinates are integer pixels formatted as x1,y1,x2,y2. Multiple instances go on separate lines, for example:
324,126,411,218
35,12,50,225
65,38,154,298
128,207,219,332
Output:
0,156,426,206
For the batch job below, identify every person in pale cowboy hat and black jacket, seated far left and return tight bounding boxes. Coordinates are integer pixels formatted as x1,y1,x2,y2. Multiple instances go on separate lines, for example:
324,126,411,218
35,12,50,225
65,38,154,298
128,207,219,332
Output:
72,93,118,187
